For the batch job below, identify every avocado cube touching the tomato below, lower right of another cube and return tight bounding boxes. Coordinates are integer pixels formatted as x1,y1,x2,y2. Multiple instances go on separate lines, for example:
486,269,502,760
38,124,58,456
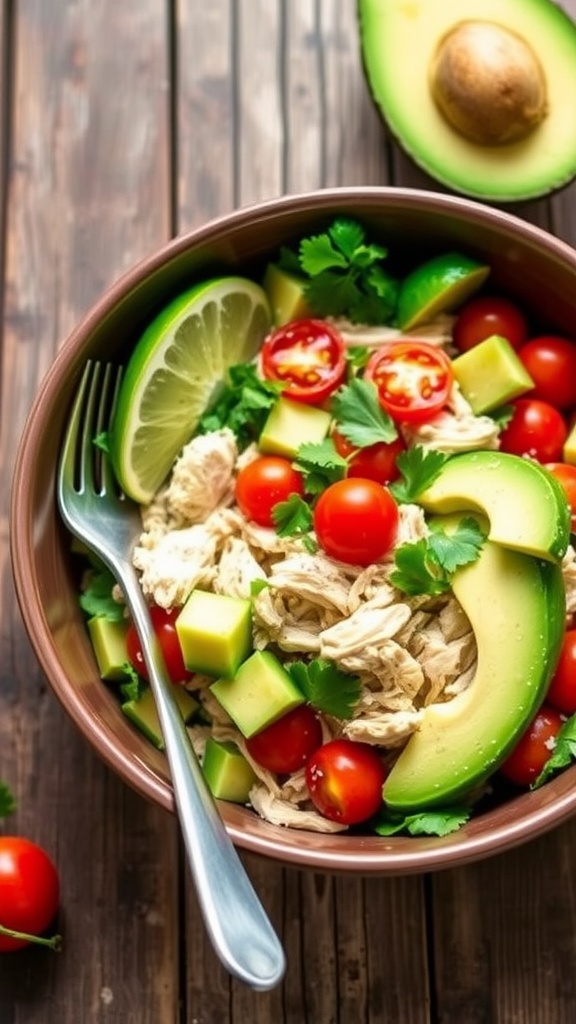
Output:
210,650,304,738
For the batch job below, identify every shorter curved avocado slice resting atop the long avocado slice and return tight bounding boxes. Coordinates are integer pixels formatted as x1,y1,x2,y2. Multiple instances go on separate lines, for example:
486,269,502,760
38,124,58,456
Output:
417,452,570,561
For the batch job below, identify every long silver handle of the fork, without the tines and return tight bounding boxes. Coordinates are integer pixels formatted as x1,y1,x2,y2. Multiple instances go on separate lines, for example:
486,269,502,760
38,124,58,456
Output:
122,564,286,991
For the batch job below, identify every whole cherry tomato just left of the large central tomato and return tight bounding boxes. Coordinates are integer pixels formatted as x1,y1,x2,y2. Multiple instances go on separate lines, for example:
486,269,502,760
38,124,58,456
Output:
236,455,304,526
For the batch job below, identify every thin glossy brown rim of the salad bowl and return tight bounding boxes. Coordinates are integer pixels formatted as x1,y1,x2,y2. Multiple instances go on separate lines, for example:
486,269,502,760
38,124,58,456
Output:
9,185,576,874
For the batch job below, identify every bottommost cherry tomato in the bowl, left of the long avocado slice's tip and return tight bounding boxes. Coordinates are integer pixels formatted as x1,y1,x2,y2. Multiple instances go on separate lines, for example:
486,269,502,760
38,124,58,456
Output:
305,739,385,825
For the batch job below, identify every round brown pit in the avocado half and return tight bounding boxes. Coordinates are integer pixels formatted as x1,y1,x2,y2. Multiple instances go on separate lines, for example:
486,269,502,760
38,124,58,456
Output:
429,20,547,145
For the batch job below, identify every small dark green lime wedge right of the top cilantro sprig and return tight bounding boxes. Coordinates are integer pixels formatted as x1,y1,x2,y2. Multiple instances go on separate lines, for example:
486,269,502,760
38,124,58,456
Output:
397,253,490,331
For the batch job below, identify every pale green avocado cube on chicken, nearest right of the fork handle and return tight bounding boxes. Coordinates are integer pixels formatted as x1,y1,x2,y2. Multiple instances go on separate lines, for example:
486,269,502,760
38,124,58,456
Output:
175,590,252,676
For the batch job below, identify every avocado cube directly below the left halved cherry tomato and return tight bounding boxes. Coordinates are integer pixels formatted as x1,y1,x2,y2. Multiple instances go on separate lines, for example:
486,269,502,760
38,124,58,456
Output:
258,395,331,459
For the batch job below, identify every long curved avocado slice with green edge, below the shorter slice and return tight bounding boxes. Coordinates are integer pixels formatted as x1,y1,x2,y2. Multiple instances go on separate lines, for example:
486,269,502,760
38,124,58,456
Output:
382,526,566,813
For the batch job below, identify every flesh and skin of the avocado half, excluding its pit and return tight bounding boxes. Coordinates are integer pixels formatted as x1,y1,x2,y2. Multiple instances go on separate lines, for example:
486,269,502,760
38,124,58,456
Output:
358,0,576,203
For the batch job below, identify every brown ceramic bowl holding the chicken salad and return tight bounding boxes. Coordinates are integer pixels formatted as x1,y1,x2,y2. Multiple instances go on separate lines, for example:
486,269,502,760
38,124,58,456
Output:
11,188,576,874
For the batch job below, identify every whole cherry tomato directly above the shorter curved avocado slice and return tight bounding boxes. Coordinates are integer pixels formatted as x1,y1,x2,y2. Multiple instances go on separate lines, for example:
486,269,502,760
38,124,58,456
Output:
500,398,568,462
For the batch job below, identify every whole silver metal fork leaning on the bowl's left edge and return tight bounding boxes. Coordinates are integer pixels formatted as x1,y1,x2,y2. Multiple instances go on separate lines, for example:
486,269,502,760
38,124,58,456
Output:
57,361,285,990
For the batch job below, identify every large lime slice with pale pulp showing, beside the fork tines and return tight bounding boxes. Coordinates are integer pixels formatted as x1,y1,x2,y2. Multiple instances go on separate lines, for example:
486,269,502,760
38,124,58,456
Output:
110,278,272,504
